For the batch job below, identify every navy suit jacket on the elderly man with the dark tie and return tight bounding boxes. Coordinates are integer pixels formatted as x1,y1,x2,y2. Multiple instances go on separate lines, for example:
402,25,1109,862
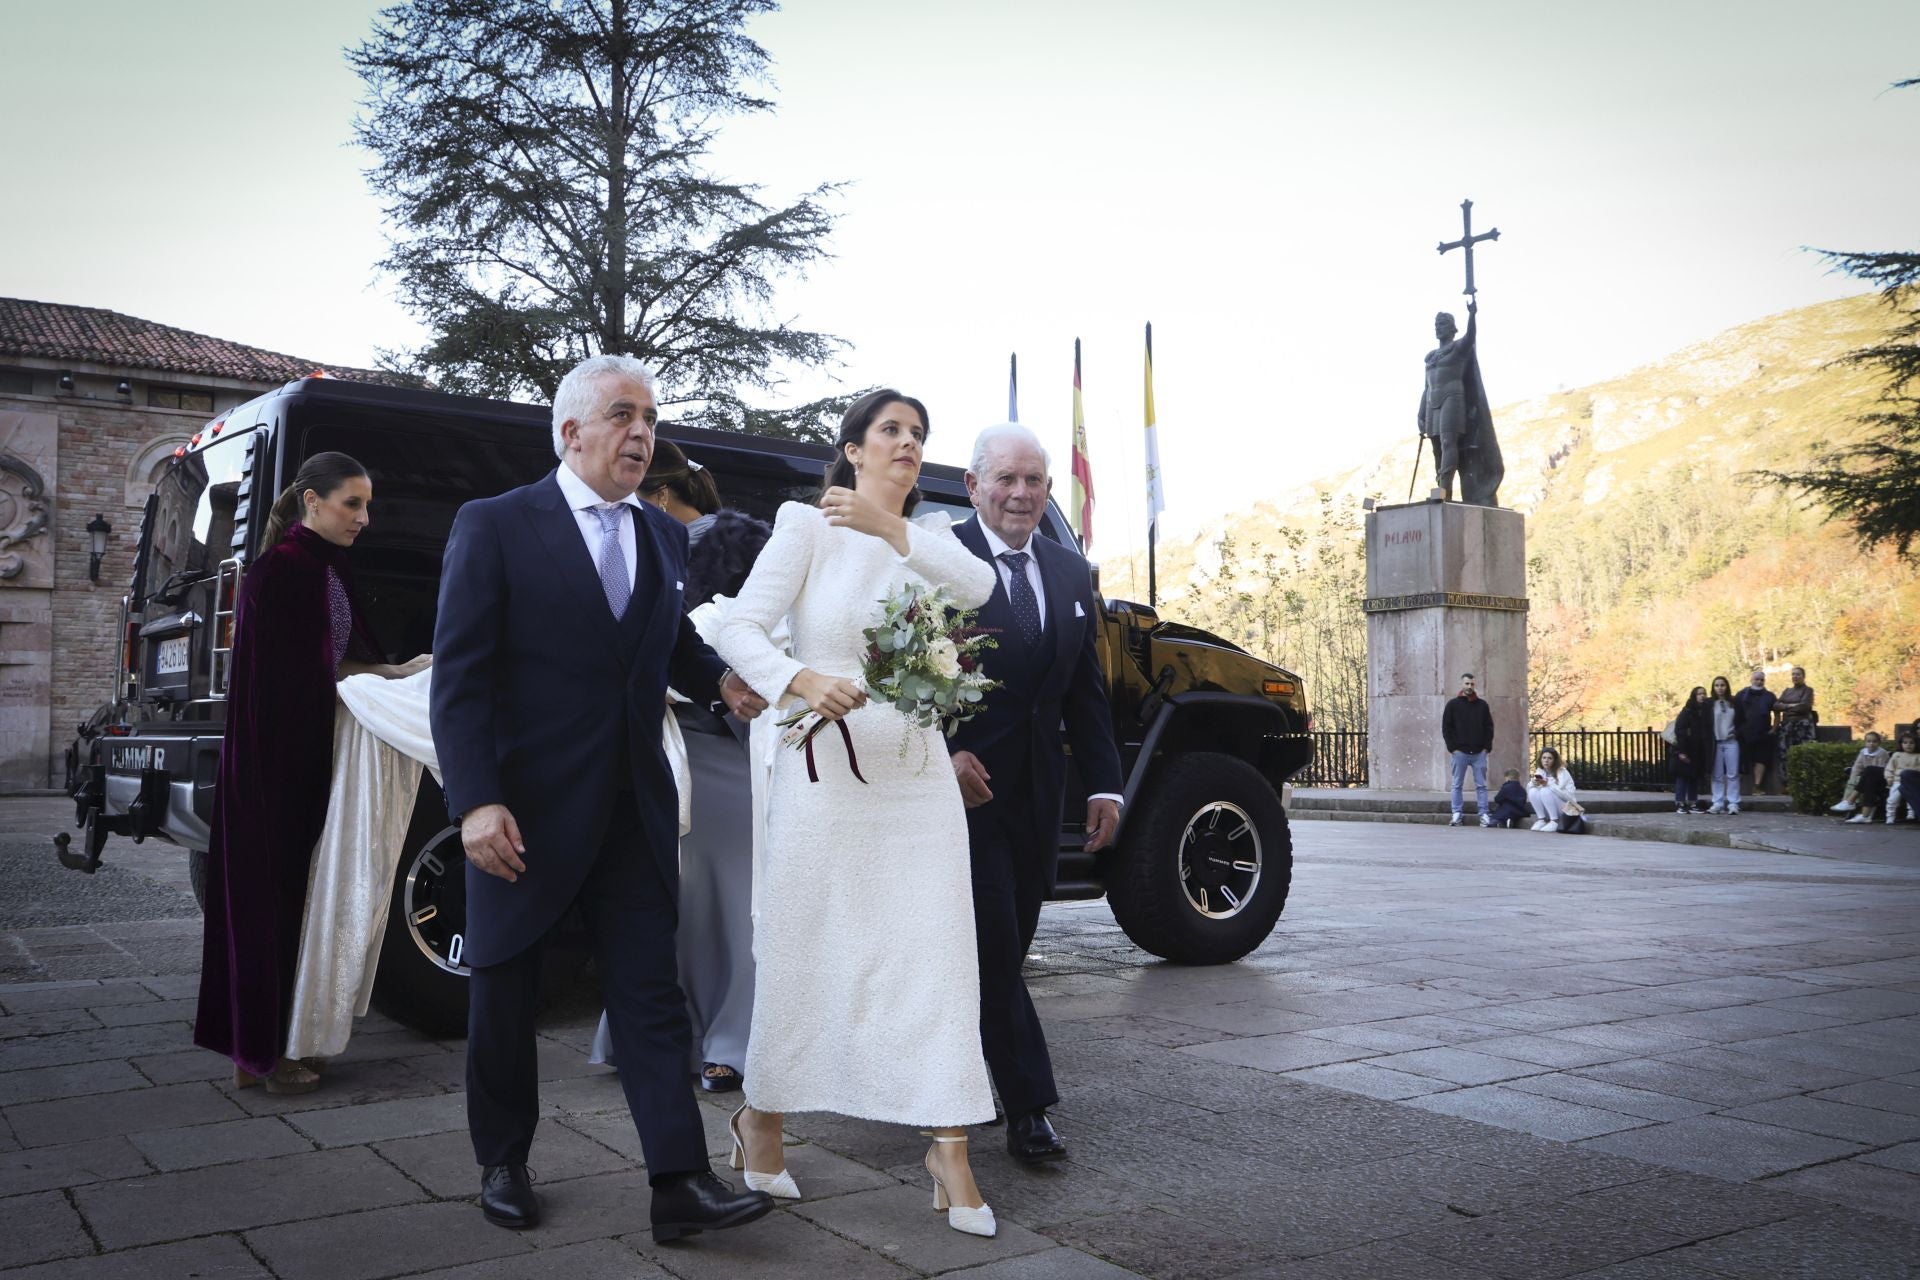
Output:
947,516,1123,892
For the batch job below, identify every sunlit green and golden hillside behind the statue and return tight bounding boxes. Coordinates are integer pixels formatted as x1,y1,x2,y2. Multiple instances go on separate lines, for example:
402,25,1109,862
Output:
1104,296,1920,727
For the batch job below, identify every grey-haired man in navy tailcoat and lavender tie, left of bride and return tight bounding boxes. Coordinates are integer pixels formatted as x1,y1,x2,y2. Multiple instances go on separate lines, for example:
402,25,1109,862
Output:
432,355,772,1240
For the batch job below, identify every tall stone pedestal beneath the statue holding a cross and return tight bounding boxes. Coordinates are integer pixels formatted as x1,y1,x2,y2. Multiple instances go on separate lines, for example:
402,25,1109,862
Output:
1365,501,1526,790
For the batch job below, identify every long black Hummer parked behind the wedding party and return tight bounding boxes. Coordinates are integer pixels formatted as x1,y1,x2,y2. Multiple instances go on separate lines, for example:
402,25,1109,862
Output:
67,378,1311,1034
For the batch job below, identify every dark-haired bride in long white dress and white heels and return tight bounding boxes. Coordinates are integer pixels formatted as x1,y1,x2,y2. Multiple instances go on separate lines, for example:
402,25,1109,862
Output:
714,390,995,1236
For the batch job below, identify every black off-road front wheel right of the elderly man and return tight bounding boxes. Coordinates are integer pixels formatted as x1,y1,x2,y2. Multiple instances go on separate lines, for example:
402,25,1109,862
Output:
1106,752,1294,965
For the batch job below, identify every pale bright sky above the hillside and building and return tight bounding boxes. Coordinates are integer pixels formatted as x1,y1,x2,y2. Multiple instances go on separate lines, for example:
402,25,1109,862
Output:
0,0,1920,555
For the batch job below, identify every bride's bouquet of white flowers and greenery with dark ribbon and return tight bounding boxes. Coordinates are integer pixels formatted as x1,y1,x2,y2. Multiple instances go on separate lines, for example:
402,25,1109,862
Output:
778,581,1000,781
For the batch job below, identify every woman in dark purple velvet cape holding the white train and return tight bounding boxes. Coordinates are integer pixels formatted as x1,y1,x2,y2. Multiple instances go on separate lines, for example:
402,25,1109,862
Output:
194,453,392,1094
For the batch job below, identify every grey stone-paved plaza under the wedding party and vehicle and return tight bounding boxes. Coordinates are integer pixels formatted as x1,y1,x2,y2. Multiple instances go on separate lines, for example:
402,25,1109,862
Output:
0,800,1920,1280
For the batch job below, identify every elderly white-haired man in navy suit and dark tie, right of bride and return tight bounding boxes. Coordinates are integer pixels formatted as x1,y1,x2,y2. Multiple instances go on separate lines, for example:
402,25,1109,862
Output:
948,422,1121,1163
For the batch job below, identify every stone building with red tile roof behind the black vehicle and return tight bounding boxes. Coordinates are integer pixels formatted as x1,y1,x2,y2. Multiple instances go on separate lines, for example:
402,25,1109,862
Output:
0,297,407,793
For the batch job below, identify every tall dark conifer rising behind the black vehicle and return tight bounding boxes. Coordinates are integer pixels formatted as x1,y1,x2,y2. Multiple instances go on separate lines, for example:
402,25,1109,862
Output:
348,0,841,436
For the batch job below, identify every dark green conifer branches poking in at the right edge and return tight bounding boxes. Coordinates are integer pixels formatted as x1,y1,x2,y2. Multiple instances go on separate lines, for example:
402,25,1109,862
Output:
1759,79,1920,557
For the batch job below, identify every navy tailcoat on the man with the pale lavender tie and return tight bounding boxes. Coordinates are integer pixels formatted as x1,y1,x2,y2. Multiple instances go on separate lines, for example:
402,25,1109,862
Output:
432,474,726,965
